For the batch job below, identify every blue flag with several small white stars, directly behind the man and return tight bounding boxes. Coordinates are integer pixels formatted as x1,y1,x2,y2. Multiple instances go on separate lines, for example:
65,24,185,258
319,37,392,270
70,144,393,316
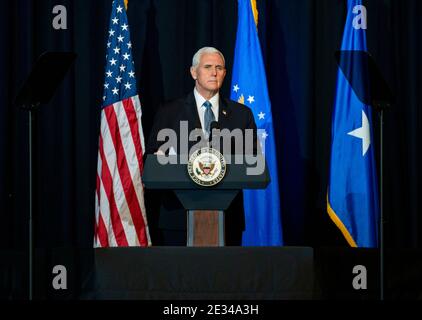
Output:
230,0,283,246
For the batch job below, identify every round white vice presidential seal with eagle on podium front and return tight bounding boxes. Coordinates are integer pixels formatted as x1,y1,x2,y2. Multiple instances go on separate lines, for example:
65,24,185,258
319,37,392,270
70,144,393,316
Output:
188,148,226,187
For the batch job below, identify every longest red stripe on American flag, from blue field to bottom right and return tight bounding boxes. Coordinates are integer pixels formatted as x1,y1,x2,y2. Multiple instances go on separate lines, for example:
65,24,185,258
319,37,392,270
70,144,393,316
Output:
104,104,148,246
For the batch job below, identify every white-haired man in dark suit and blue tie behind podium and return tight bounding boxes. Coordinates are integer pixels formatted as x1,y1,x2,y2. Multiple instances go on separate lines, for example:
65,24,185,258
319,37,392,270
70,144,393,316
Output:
146,47,256,246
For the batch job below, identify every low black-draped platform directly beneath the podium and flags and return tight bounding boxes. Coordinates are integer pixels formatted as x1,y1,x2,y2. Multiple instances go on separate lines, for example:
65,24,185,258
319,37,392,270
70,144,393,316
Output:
90,247,314,300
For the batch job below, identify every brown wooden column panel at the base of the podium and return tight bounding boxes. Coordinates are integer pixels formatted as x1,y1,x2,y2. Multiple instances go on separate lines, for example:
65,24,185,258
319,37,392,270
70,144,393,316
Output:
187,210,225,247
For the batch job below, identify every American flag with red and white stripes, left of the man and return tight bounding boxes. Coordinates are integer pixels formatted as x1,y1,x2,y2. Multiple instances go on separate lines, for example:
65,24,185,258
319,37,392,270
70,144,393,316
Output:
94,0,151,247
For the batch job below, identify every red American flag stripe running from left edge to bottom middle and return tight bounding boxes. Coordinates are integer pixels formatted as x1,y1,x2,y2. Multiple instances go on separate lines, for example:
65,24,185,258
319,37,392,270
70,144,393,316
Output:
100,131,128,247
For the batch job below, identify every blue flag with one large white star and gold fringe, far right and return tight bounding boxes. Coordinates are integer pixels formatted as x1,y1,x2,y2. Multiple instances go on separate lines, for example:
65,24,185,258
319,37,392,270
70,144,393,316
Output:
327,0,379,247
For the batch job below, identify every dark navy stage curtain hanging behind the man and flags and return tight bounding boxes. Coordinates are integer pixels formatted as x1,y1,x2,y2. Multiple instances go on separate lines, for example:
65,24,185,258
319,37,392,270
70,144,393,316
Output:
0,0,422,249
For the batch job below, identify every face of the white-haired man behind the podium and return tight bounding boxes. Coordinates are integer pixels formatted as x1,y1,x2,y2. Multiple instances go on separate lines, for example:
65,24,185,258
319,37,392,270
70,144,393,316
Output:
191,53,226,98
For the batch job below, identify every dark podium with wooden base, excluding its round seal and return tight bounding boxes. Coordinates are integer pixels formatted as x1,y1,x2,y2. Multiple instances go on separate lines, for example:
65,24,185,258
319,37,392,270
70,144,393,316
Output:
142,155,270,247
